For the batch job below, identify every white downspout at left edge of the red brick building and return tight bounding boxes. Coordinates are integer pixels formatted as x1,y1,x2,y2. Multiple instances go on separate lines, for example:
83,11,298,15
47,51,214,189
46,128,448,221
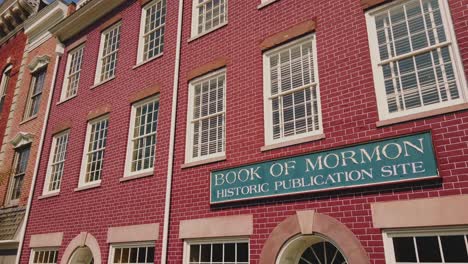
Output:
15,43,64,264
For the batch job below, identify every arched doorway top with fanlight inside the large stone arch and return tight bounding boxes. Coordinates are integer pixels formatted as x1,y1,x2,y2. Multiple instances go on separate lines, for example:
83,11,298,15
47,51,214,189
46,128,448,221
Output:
276,235,348,264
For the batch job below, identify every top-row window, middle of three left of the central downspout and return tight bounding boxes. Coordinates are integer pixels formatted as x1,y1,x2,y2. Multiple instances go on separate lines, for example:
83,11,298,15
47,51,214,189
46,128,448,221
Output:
95,22,120,84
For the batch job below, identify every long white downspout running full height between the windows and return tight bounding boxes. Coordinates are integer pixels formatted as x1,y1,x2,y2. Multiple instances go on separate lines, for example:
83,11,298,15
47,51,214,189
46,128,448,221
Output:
161,0,184,264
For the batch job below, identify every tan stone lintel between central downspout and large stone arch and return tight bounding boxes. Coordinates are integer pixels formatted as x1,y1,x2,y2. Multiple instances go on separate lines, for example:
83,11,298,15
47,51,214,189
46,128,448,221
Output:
179,215,253,239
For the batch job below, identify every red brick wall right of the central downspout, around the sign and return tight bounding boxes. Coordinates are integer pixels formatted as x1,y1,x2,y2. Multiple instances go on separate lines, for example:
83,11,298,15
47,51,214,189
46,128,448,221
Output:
168,0,468,264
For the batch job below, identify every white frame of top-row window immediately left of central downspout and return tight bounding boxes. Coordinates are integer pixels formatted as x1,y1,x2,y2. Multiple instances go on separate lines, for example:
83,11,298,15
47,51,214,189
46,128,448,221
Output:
137,0,167,65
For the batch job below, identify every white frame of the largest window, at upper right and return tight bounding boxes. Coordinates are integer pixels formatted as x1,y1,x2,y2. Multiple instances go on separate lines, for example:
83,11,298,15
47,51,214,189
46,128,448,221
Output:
366,0,468,120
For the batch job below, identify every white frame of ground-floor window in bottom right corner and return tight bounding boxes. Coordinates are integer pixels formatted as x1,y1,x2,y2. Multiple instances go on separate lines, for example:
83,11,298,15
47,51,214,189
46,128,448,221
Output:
382,227,468,264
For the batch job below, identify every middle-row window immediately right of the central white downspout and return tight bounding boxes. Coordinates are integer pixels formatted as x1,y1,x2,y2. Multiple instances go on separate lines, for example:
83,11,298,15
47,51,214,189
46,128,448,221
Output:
186,70,226,162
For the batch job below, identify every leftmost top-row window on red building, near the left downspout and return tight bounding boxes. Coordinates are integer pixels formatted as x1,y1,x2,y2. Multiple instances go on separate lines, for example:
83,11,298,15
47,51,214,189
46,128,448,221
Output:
61,45,84,101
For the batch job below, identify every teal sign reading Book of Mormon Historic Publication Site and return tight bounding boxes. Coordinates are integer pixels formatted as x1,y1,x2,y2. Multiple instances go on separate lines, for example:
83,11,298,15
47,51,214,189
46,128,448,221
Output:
211,133,438,204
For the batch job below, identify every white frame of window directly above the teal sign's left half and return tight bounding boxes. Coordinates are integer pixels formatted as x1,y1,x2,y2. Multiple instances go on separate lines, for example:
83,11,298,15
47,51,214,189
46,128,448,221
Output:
263,34,323,146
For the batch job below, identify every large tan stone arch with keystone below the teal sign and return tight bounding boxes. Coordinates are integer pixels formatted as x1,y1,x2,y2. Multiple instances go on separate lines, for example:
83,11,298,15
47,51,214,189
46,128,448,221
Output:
259,211,370,264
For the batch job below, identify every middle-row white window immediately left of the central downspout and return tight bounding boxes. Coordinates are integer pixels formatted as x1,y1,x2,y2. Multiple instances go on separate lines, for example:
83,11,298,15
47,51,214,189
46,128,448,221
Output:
126,96,159,176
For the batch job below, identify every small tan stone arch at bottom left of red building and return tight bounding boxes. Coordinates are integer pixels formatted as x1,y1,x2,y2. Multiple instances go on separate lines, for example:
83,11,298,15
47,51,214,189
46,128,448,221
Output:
60,232,101,264
